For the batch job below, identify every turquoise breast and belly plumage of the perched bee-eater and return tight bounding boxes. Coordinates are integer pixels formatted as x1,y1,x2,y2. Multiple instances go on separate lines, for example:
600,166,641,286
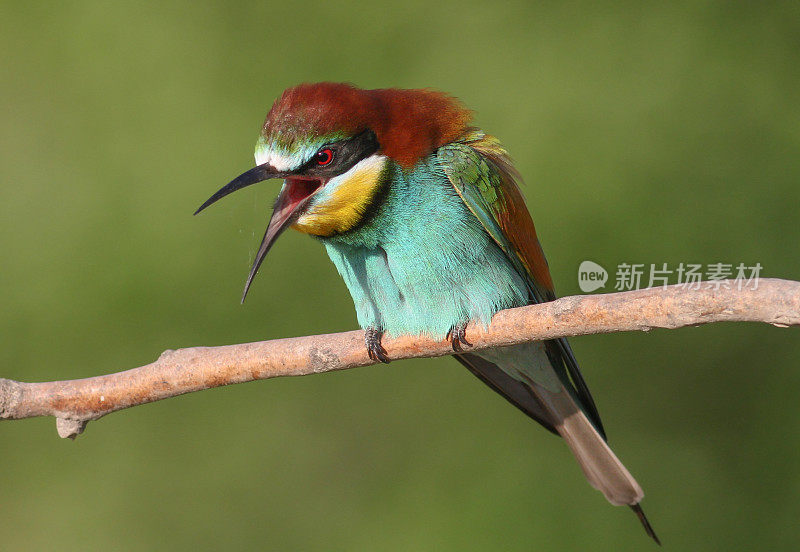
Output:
322,157,529,339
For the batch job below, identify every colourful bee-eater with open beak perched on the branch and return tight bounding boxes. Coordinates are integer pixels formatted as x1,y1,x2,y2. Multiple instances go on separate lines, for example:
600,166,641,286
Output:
195,82,658,542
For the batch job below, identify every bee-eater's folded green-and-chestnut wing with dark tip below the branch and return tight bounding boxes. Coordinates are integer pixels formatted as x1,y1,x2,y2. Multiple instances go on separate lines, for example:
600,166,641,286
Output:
436,129,605,437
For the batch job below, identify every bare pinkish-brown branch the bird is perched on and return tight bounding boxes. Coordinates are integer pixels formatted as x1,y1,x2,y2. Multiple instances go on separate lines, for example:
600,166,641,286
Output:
0,278,800,438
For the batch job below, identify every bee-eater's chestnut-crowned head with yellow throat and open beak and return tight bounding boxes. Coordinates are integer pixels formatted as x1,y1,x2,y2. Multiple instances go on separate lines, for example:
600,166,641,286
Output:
195,82,471,301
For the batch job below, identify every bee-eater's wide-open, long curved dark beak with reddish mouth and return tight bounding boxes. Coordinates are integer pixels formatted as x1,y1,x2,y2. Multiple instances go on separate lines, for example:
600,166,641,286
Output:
194,163,322,303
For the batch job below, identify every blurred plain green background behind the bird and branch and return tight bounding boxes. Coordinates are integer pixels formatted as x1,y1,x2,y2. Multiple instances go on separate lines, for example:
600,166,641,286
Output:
0,1,800,551
